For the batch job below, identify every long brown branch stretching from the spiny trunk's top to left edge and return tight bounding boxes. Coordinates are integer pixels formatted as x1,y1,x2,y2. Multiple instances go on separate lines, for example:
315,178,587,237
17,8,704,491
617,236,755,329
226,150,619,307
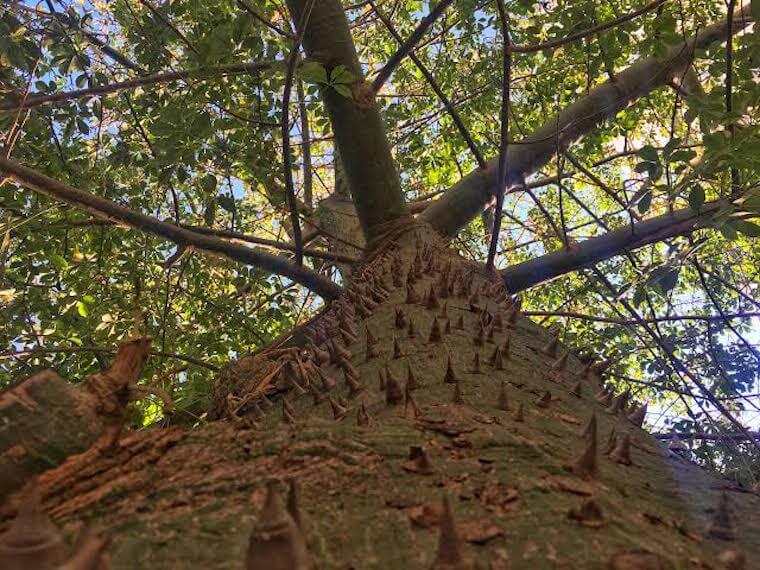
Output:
0,157,342,299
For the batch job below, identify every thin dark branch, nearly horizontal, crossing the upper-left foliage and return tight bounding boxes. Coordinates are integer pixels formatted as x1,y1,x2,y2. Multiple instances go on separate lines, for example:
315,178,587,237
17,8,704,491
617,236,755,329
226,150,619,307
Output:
0,61,279,111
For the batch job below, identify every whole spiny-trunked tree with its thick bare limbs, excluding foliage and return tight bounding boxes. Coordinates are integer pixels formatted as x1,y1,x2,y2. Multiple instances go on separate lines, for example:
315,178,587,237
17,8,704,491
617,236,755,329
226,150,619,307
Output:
0,0,760,569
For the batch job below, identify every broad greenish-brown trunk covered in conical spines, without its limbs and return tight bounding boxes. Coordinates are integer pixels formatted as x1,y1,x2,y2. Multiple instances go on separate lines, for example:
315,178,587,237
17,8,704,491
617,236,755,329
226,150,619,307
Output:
5,226,760,569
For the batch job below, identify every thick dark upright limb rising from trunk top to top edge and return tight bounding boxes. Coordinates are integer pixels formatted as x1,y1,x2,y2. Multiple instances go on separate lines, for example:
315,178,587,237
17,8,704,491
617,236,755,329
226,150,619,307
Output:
288,0,408,242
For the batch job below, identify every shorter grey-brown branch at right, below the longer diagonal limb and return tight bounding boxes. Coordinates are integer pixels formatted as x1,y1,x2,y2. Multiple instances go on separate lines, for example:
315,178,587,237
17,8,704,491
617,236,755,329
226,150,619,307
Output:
502,197,727,293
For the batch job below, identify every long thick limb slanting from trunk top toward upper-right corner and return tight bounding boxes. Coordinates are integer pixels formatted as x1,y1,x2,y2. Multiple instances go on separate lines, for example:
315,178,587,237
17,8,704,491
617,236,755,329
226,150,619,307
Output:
420,8,752,236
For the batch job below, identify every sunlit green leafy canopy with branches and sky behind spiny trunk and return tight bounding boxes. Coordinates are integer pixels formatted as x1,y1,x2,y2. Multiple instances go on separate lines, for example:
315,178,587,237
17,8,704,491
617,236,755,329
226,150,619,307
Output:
0,0,760,481
